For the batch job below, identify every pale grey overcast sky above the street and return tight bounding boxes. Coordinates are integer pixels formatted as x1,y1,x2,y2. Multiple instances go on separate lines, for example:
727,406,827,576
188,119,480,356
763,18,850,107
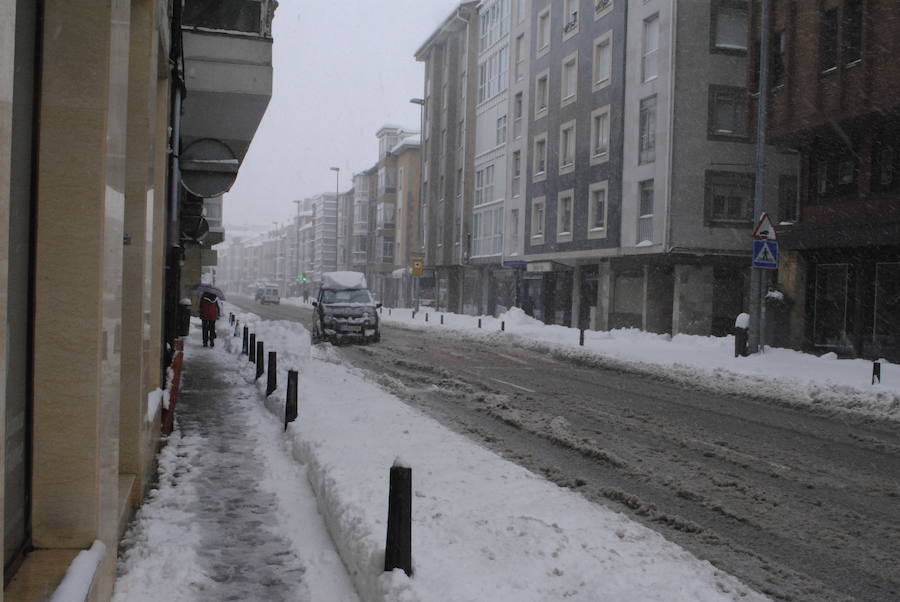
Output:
223,0,458,226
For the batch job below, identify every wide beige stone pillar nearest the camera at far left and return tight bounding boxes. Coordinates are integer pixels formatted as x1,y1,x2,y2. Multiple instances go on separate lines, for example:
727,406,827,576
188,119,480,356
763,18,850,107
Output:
32,0,130,599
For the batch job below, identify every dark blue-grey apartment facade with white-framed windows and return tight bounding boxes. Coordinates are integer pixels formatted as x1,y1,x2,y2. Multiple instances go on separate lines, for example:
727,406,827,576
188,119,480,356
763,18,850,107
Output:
522,0,627,328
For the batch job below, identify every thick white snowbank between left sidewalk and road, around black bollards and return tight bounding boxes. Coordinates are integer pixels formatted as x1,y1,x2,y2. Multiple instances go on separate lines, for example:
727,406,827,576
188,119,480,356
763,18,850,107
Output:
223,304,764,602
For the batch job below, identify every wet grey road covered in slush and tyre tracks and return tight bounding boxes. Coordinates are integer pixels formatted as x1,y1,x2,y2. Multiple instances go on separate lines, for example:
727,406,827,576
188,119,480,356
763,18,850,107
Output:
231,298,900,601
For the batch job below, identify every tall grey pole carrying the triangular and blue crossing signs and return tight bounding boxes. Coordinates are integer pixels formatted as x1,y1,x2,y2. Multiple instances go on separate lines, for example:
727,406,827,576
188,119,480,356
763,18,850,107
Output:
747,0,769,353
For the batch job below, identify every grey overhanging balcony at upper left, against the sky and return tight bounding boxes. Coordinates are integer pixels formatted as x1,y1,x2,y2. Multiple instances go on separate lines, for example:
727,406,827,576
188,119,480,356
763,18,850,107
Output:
182,0,276,183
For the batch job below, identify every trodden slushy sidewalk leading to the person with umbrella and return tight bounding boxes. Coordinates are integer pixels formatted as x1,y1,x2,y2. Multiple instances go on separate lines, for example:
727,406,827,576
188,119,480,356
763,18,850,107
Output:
115,322,357,602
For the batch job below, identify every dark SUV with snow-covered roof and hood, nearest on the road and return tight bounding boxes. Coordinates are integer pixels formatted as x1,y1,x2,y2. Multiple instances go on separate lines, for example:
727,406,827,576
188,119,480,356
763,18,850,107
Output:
310,272,381,343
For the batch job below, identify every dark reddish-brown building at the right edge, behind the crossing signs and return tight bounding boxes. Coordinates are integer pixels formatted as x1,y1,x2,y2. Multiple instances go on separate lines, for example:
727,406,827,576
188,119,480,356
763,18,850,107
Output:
764,0,900,360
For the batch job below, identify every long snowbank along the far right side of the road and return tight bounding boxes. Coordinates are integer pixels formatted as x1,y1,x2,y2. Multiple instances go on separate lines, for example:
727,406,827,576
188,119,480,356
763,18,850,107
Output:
380,308,900,420
